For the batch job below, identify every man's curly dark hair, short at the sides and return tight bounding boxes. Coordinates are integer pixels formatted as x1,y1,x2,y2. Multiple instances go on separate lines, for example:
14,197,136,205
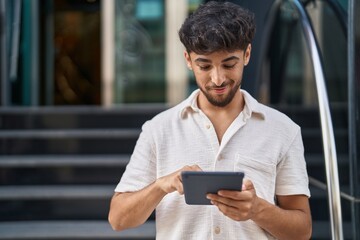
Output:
179,1,256,54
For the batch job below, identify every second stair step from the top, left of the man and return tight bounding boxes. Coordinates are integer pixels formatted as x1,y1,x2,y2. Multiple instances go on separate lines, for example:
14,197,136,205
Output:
0,129,141,155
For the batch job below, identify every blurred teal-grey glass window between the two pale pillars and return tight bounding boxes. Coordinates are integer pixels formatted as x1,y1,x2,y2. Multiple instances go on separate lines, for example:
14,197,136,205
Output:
114,0,165,103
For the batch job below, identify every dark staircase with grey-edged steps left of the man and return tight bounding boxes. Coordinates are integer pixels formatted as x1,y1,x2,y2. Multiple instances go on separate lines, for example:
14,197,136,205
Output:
0,105,165,240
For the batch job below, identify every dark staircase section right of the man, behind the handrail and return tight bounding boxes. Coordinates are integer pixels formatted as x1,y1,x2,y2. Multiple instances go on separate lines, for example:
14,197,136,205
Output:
273,104,352,240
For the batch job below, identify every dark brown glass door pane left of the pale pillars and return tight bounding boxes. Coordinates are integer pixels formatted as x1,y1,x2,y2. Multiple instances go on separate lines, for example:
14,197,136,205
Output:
51,0,101,105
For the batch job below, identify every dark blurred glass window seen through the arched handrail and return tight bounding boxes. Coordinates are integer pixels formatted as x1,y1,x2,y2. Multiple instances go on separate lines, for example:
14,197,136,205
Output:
259,2,317,106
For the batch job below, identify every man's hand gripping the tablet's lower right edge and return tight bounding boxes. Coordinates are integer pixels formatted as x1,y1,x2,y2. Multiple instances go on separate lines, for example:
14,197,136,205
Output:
207,180,258,221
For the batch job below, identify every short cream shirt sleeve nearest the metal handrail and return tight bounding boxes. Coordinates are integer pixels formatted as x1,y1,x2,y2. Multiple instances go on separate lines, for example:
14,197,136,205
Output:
275,128,310,197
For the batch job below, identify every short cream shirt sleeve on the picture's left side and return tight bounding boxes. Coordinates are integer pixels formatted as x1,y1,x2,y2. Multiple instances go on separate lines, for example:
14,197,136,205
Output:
115,122,156,192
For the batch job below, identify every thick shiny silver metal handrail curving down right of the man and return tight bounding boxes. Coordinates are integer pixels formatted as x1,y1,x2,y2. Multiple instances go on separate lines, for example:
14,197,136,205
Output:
291,0,344,240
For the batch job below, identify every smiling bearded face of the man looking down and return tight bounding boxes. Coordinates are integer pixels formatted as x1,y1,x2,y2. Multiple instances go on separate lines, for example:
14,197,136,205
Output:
185,45,251,107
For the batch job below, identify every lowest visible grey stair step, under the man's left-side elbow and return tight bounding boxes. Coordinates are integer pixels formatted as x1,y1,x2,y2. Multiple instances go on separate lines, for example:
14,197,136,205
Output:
0,221,156,240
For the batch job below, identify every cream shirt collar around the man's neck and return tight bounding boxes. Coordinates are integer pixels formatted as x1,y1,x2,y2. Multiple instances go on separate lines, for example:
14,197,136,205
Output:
180,89,265,119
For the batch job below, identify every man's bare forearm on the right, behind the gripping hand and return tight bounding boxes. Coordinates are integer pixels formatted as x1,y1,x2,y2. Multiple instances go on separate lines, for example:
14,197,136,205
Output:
252,199,312,240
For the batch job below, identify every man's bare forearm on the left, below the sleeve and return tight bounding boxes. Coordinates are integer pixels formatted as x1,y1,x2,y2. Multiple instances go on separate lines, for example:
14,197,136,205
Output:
109,182,166,231
